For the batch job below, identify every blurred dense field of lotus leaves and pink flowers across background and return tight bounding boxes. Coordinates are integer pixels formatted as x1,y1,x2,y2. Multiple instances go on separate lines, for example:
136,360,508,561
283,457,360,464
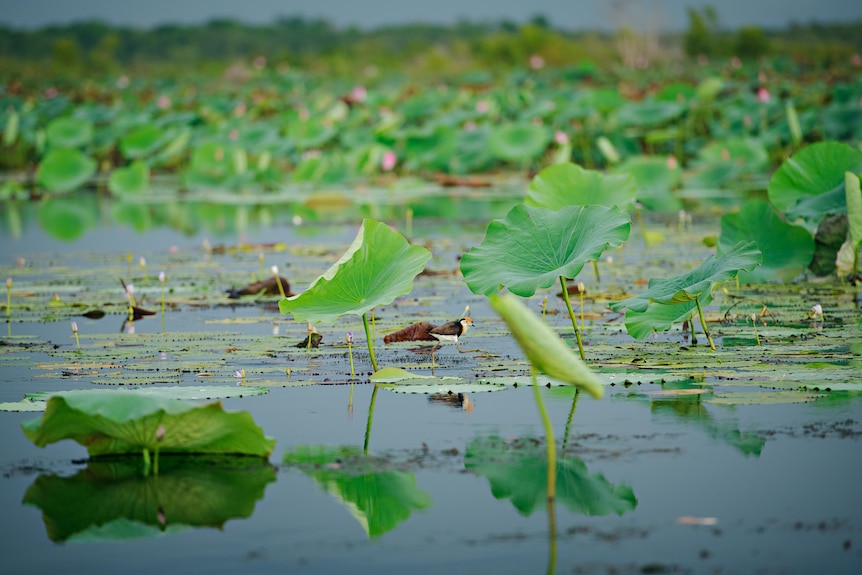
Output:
5,60,862,202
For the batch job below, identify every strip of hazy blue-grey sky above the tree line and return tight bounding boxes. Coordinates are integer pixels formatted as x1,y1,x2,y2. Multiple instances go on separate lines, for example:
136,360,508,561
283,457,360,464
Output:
0,0,862,30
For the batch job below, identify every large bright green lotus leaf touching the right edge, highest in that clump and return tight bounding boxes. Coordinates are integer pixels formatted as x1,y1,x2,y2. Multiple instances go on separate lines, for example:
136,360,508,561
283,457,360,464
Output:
769,142,862,223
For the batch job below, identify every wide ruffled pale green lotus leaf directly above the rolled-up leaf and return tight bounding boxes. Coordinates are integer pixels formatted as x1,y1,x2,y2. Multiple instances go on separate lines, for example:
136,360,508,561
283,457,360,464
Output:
461,204,631,297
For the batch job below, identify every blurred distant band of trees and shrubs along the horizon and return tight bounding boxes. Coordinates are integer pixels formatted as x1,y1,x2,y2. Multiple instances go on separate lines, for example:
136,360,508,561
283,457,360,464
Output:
0,7,862,78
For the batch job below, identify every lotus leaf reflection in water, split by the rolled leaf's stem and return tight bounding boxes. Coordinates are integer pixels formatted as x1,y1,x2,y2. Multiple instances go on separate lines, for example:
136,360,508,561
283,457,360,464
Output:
464,437,638,516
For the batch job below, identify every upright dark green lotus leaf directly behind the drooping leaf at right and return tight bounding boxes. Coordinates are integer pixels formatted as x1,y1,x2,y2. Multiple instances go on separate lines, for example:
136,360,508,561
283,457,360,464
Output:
718,200,814,283
